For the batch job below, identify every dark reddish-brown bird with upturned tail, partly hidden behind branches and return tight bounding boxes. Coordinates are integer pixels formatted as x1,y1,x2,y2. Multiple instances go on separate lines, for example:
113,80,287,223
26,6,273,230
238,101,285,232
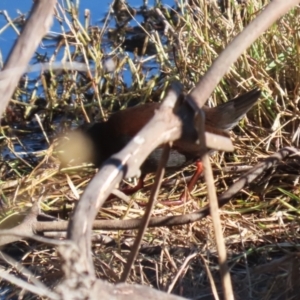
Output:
59,88,261,202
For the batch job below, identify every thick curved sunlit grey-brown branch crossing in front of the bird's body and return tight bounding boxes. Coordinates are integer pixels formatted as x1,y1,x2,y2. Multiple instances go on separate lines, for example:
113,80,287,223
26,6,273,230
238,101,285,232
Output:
68,83,182,274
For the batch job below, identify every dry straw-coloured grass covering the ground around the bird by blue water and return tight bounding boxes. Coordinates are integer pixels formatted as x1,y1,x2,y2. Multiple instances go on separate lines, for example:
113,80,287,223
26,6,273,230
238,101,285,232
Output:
1,0,300,300
